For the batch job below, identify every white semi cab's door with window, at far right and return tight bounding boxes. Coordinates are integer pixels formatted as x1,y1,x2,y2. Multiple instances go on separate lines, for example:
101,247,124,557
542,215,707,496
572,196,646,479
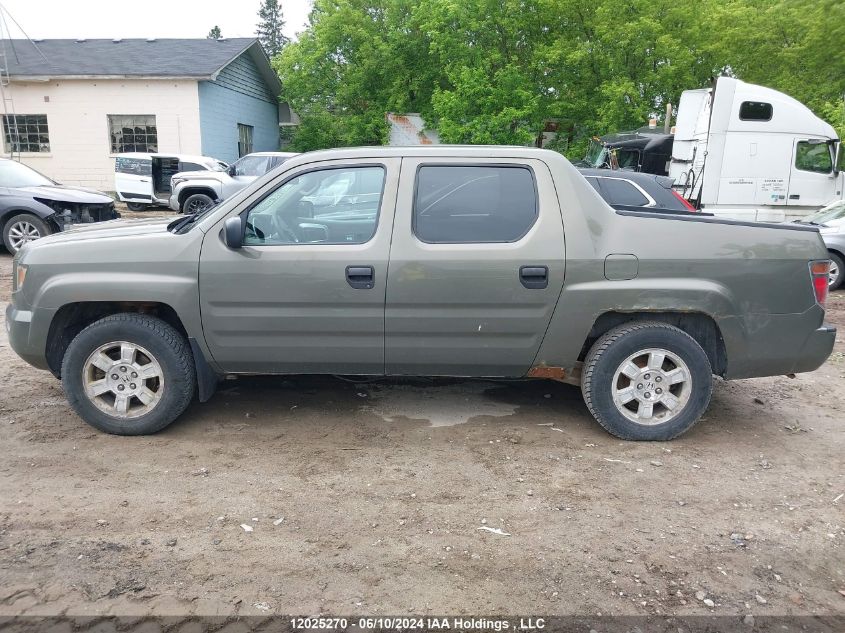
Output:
787,139,840,208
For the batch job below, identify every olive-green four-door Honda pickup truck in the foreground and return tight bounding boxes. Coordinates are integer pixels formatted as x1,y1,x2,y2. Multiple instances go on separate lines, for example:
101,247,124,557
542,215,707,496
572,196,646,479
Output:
6,146,836,440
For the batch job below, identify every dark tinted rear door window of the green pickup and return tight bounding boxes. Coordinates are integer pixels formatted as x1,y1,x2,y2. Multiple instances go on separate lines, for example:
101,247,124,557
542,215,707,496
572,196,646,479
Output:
413,165,538,244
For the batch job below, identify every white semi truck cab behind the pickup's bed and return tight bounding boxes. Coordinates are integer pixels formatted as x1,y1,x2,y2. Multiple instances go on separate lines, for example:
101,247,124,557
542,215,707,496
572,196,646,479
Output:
669,77,845,222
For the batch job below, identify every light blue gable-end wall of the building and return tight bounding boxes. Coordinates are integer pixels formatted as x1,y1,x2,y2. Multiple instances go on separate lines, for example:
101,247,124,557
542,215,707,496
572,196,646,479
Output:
199,53,279,163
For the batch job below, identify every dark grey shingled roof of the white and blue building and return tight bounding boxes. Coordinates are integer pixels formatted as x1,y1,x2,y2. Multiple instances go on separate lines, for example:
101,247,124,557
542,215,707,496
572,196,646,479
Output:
4,37,282,96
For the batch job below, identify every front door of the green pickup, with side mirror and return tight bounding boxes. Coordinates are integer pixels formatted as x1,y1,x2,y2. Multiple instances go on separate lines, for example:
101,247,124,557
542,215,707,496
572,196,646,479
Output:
199,158,400,375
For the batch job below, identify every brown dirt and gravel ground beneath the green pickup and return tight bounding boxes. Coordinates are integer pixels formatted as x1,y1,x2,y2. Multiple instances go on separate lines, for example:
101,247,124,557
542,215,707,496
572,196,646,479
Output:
0,238,845,616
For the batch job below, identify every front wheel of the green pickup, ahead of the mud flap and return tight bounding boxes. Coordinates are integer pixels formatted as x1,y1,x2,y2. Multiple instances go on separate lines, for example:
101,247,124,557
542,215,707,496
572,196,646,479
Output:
62,313,196,435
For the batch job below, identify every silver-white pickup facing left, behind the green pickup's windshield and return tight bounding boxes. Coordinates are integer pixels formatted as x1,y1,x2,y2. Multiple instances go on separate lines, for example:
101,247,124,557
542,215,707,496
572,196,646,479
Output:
170,152,296,214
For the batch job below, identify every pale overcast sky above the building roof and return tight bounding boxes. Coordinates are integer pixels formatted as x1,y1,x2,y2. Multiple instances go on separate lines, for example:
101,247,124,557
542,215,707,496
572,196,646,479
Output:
0,0,311,39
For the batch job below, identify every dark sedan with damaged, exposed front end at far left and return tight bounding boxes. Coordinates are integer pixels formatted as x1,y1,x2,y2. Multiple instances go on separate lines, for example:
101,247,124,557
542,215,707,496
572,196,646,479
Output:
0,158,120,254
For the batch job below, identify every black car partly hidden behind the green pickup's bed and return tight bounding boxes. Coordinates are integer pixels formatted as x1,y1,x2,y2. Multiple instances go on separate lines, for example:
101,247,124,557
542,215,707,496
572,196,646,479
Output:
578,169,697,213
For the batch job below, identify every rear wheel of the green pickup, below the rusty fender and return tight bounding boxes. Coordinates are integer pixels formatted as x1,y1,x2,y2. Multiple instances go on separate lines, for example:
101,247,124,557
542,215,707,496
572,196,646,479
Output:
581,321,713,441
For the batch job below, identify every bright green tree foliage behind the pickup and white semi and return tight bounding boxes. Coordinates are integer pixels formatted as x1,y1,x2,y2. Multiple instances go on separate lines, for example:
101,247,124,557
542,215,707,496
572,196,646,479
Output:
276,0,845,154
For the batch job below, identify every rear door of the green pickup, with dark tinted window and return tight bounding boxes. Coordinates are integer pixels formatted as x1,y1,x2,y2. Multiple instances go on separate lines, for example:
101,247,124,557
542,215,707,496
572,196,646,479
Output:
385,157,565,376
